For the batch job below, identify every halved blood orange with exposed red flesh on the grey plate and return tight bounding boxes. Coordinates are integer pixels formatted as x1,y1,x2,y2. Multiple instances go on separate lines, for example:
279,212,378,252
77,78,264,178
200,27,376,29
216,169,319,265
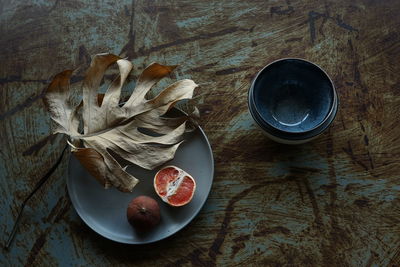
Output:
154,166,196,207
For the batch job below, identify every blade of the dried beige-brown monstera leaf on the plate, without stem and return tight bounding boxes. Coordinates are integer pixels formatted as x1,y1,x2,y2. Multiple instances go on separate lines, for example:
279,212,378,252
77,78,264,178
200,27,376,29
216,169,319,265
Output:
45,54,197,191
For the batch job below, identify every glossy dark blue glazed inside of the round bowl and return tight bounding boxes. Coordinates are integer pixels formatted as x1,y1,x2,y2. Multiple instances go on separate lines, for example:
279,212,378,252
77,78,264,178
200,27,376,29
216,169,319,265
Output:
253,59,334,133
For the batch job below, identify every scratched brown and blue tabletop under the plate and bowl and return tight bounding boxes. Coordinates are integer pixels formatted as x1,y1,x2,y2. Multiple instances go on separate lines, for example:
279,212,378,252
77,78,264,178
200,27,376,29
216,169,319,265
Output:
0,0,400,266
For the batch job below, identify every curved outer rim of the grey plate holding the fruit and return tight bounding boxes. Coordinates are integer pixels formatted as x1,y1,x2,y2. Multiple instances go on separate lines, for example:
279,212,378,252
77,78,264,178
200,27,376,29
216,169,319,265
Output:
66,126,215,245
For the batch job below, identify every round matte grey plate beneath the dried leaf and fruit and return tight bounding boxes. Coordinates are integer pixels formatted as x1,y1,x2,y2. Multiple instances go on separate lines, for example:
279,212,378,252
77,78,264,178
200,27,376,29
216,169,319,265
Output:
67,128,214,244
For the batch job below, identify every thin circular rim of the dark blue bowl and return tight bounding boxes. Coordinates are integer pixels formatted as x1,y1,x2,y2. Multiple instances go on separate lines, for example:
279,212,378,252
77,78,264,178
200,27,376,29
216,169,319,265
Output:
248,57,338,137
